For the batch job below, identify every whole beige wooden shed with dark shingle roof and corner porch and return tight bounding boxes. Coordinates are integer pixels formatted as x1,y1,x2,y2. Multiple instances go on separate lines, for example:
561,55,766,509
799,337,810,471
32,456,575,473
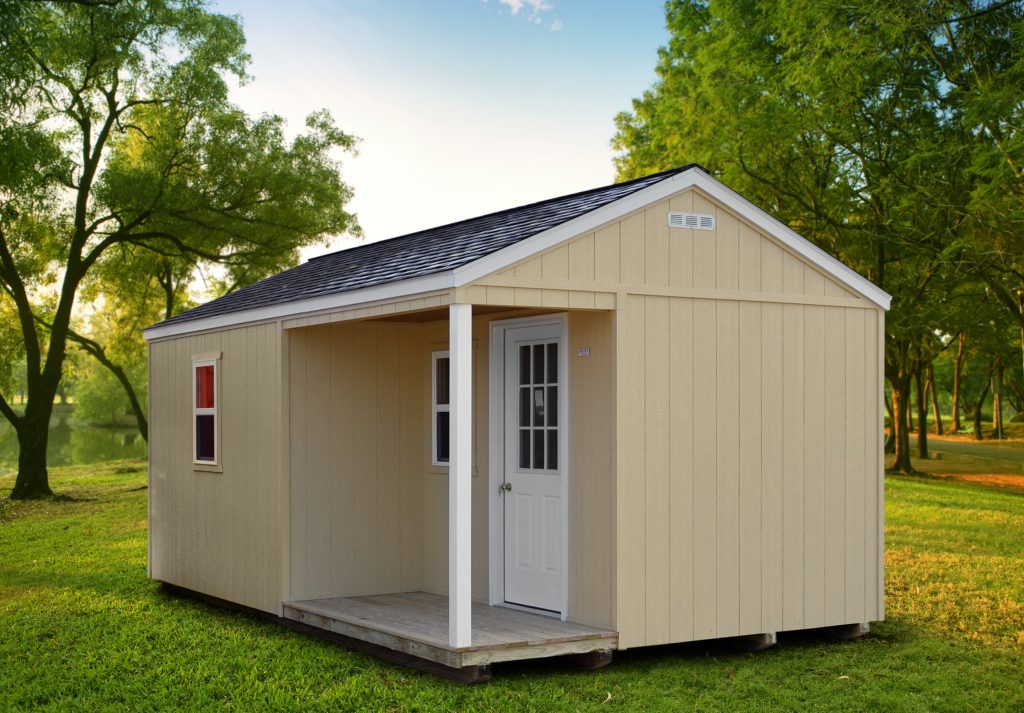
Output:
145,165,889,677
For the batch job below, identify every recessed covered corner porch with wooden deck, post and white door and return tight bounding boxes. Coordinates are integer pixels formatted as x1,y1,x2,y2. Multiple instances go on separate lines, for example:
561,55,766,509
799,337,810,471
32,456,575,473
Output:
282,303,617,669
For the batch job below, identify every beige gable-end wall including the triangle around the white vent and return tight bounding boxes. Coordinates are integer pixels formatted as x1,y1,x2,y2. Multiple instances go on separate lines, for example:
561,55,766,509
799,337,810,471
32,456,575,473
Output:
468,182,883,647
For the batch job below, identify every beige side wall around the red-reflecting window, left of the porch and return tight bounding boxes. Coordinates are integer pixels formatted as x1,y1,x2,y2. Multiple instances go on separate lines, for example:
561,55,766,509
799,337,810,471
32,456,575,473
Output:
150,324,284,614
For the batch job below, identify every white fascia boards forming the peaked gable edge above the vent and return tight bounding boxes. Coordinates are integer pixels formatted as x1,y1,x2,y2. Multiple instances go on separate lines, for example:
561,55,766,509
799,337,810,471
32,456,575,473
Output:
454,168,892,310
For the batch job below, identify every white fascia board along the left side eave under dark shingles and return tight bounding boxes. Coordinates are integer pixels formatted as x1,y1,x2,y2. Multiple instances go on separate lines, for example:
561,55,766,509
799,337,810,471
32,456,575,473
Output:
142,271,454,341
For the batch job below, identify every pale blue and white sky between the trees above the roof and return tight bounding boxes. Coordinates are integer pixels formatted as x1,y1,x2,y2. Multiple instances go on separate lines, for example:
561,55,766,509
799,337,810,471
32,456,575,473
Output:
213,0,668,258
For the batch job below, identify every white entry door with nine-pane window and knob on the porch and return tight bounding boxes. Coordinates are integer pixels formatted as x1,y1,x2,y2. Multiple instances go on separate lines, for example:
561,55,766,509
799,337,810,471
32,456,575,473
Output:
501,325,566,612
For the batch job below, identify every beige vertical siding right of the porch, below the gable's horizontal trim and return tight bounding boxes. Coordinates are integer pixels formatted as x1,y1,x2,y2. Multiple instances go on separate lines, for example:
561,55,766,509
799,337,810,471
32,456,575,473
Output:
616,295,880,647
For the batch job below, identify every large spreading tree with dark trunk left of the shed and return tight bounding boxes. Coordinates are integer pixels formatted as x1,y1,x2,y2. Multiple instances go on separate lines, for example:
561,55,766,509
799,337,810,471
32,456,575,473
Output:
0,0,357,498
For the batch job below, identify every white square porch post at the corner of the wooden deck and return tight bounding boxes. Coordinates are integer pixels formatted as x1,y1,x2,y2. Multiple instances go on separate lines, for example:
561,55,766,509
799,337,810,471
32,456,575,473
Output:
449,304,473,646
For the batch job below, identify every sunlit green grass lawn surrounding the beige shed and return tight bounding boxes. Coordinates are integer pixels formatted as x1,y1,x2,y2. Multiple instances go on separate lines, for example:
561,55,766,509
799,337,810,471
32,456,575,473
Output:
0,463,1024,713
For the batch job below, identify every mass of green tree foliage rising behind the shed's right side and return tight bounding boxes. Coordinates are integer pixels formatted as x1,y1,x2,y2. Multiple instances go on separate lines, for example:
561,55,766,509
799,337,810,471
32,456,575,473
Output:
613,0,1024,470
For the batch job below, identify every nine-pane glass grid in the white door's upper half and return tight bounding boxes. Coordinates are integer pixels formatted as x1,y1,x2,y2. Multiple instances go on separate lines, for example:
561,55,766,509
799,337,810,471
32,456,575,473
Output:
518,342,558,470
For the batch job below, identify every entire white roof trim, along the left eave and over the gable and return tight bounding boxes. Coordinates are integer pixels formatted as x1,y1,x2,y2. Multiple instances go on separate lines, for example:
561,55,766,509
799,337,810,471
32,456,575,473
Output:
148,168,892,340
